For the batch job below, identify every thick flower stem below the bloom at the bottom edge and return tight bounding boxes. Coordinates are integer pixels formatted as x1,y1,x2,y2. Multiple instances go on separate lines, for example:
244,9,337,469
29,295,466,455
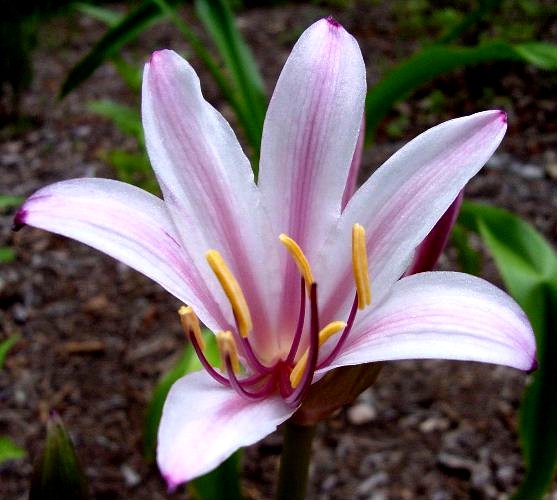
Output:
275,421,315,500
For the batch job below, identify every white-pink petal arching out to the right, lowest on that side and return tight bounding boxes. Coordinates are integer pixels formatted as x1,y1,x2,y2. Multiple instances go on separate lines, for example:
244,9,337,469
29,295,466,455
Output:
320,272,536,370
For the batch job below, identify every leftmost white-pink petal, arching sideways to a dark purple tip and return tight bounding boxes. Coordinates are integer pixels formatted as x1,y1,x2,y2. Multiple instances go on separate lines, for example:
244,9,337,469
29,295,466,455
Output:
16,179,226,328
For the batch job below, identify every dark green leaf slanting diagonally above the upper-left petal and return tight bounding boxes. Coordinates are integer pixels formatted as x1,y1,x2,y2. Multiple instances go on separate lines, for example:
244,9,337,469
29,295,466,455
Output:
60,1,162,98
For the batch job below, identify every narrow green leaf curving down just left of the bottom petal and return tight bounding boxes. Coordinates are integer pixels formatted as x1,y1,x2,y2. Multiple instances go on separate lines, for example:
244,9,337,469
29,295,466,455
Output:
143,330,219,461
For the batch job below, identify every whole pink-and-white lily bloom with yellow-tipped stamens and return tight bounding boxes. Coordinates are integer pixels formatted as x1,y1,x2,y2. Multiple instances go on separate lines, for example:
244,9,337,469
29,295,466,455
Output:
15,18,535,487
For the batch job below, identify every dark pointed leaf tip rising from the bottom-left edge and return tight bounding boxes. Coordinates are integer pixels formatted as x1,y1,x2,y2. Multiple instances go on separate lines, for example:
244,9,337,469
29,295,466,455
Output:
29,415,90,500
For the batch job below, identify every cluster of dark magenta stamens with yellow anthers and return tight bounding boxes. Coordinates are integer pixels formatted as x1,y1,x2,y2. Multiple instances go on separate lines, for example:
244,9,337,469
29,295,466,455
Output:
178,224,371,408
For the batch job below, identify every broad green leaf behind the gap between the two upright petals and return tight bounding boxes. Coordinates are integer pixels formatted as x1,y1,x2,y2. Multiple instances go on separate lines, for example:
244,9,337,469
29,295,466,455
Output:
195,0,267,160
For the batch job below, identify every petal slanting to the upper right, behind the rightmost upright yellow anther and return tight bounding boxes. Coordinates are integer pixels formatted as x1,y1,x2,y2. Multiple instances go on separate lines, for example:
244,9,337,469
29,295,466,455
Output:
316,111,507,322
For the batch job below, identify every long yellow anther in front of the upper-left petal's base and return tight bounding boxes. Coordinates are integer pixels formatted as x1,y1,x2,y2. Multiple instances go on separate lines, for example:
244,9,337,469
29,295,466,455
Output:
205,250,253,337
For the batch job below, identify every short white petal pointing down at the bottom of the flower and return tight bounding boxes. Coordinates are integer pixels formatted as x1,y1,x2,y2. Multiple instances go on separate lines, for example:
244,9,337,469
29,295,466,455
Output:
157,371,295,488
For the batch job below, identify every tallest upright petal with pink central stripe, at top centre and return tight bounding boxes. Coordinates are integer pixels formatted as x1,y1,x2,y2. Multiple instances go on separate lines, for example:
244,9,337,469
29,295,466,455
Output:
259,19,366,354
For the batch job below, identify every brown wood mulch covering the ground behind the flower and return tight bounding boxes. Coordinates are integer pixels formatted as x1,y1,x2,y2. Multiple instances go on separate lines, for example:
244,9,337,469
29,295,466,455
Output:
0,2,557,500
